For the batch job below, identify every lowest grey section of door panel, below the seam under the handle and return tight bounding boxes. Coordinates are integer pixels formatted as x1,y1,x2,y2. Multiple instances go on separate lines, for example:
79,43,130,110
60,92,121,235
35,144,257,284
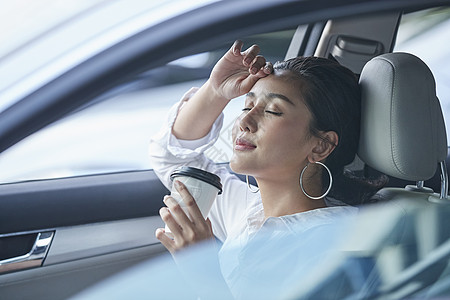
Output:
0,244,163,299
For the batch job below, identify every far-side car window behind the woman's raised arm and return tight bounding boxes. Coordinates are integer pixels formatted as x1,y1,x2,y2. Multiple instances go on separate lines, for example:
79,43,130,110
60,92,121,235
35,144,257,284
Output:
0,30,294,183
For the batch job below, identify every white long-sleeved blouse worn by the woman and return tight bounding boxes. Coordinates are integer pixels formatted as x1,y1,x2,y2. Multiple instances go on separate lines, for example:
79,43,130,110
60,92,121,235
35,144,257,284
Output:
150,89,357,298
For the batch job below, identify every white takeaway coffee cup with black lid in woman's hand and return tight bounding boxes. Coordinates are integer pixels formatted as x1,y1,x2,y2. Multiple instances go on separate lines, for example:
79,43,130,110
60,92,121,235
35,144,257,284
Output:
165,166,222,236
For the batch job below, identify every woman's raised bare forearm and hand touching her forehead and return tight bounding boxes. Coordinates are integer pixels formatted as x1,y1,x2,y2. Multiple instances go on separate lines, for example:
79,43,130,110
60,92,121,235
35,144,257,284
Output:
172,41,273,140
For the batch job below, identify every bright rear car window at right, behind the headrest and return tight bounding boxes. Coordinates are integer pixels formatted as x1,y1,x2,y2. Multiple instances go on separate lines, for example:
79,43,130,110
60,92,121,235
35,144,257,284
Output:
394,8,450,142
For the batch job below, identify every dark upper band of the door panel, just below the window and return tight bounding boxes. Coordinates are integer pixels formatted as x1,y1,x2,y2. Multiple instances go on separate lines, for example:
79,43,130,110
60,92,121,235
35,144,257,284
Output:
0,171,168,234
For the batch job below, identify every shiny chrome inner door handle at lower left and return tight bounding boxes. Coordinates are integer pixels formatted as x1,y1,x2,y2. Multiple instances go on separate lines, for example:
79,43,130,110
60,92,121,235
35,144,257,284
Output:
0,231,54,274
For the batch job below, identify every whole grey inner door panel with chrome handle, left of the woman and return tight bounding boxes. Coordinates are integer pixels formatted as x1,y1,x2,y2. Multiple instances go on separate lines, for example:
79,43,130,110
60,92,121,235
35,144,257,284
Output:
0,171,168,299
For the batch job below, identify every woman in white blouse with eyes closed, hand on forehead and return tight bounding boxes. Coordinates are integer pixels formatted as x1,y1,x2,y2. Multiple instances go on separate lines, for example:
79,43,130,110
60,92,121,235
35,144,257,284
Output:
150,41,384,298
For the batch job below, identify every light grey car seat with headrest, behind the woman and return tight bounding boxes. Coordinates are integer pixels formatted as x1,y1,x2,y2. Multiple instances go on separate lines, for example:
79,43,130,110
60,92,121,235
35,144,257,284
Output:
358,53,450,297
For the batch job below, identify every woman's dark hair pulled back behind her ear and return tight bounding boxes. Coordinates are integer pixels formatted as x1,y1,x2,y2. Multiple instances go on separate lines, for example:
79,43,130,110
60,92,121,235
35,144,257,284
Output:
274,57,387,205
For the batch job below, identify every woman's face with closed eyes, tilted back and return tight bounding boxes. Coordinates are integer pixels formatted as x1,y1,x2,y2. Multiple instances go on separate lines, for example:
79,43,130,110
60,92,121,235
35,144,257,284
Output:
230,71,316,178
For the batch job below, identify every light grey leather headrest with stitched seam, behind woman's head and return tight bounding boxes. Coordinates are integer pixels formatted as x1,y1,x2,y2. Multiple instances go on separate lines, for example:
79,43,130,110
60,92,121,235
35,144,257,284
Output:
358,53,447,181
